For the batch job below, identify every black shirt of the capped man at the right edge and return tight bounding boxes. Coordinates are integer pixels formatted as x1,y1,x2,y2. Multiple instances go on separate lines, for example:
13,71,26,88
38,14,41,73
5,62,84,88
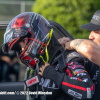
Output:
85,59,100,100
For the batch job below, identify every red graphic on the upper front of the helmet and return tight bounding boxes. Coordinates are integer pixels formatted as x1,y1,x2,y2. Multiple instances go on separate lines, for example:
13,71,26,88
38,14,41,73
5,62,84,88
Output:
11,13,29,28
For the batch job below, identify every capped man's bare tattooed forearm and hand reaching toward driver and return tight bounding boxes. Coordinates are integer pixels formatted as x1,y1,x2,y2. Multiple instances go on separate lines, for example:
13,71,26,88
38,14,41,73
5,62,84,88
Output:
59,38,100,66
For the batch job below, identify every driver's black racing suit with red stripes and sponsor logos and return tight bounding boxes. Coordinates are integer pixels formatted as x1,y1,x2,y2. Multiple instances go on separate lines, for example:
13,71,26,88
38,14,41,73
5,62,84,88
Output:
27,35,94,100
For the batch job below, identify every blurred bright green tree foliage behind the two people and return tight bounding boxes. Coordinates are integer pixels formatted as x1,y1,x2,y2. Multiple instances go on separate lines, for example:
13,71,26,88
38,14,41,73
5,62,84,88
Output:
32,0,100,38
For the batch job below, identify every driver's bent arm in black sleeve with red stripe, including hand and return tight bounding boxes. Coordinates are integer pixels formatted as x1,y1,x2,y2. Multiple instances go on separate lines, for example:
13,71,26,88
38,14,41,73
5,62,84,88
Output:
39,58,93,100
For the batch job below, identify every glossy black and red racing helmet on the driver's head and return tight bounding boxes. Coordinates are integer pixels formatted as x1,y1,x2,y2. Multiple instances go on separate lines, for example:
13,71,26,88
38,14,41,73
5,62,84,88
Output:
2,12,53,67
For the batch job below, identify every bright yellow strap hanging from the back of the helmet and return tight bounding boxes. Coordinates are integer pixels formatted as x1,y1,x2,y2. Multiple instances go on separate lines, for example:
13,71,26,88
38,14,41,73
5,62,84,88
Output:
40,29,53,63
